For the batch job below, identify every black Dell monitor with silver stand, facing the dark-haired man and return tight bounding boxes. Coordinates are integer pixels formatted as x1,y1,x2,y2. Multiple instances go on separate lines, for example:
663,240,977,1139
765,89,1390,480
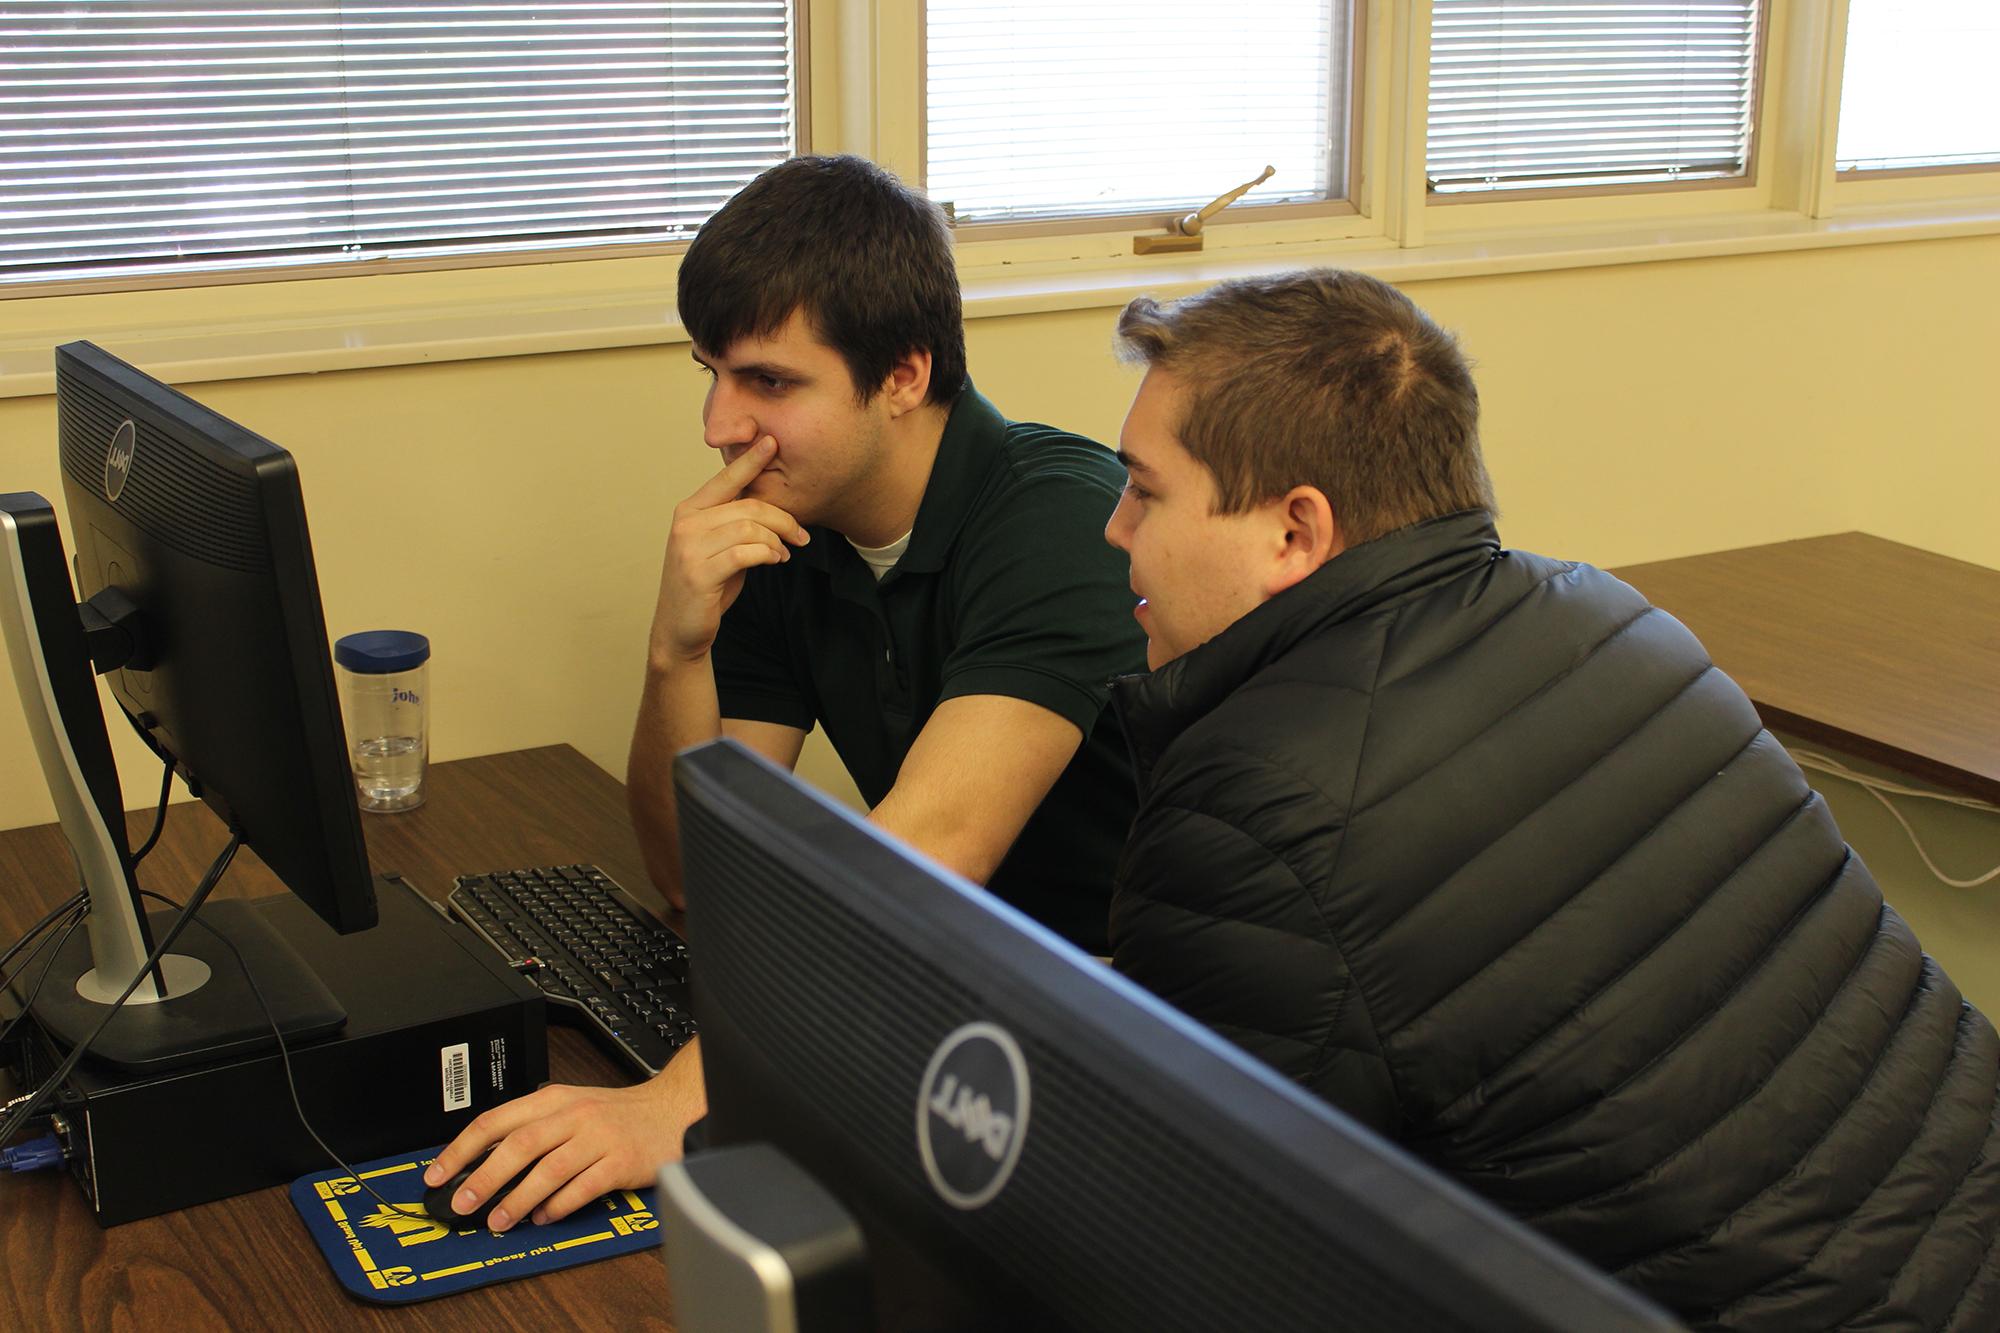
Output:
0,342,376,1071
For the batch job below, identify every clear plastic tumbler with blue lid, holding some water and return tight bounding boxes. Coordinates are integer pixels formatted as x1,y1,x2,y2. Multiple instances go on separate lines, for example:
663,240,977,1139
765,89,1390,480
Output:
334,630,430,811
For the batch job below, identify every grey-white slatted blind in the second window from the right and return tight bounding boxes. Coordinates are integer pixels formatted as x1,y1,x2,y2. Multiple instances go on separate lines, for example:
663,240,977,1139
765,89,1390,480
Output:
1426,0,1758,194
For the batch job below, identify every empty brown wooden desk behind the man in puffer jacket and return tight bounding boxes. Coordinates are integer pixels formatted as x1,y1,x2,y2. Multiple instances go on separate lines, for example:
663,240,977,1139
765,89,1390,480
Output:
1612,532,2000,803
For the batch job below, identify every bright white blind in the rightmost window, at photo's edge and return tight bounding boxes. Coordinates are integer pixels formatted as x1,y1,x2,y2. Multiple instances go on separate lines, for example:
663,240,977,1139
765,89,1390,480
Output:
1834,0,2000,172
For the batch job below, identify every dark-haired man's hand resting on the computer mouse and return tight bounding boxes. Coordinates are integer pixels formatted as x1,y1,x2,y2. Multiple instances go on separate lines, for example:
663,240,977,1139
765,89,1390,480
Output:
424,1043,708,1231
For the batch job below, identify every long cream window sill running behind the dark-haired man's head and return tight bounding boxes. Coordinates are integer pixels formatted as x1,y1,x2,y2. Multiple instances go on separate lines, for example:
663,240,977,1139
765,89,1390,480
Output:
0,196,2000,398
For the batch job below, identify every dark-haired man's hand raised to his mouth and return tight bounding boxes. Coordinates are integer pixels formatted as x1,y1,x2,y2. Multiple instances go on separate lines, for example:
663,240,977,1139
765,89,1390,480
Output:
652,434,808,667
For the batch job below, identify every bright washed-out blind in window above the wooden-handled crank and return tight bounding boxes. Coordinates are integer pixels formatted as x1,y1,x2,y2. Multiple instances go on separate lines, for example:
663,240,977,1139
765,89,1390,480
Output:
924,0,1350,222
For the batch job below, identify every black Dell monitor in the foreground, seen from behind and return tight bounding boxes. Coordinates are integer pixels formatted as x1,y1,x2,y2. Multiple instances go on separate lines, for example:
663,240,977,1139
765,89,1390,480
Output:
664,741,1678,1333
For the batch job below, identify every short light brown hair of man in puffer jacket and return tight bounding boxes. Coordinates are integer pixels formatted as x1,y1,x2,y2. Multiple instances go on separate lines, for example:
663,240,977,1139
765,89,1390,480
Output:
1118,268,1494,546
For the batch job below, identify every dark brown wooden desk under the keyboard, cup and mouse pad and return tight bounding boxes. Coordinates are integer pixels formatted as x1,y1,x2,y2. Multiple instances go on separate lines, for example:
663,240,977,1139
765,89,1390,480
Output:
0,745,672,1333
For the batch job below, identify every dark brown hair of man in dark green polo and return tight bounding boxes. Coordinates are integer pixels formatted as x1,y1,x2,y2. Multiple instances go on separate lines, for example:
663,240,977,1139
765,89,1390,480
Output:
680,156,966,404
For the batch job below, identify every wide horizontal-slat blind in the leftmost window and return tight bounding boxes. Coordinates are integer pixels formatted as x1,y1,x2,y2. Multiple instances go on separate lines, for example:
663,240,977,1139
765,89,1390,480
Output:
0,0,794,282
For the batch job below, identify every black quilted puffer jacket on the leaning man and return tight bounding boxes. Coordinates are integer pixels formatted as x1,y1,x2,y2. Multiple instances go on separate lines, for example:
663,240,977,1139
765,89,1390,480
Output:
1112,512,2000,1331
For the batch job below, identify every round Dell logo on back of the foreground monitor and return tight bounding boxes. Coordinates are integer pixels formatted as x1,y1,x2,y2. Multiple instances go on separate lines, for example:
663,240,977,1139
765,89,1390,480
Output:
916,1023,1028,1209
